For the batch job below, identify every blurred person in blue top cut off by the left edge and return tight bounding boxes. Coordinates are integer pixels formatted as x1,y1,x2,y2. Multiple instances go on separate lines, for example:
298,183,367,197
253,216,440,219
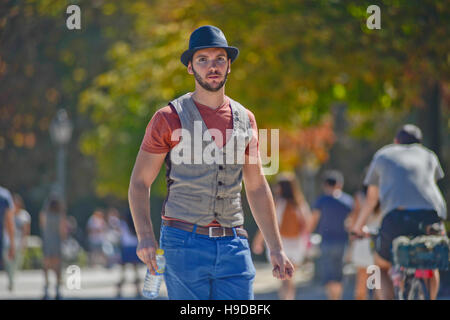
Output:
0,186,16,270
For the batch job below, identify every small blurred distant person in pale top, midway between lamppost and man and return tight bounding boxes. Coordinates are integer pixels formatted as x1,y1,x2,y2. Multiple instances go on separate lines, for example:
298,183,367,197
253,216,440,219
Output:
87,208,107,266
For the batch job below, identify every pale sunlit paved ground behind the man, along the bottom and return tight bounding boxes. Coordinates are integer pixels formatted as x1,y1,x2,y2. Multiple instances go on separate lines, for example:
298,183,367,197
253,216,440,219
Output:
0,262,450,300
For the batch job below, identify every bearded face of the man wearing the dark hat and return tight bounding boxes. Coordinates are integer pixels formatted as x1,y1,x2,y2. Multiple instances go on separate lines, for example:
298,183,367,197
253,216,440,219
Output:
188,48,231,92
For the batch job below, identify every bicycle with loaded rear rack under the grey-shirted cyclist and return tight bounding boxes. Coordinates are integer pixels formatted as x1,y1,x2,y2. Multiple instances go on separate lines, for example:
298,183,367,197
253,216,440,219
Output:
350,223,450,300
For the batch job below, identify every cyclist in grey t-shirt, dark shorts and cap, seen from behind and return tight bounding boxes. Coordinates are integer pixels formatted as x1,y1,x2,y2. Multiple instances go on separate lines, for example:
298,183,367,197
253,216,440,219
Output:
352,124,447,299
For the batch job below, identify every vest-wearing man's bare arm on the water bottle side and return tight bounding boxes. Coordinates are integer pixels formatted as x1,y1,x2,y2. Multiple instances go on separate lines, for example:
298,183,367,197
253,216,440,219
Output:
128,150,166,272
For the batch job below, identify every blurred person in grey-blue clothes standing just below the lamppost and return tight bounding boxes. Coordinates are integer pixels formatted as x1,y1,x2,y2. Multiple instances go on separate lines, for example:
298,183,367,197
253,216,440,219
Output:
39,195,67,299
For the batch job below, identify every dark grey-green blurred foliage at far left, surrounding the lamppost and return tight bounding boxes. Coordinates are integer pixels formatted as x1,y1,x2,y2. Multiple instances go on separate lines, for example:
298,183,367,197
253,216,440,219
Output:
0,0,131,225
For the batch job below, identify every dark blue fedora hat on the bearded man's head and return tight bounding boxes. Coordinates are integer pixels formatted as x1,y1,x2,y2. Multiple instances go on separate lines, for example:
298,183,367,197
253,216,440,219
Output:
181,26,239,67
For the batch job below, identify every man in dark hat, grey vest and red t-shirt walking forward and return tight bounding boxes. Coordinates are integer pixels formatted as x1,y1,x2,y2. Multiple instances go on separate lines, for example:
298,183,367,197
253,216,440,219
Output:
129,26,293,300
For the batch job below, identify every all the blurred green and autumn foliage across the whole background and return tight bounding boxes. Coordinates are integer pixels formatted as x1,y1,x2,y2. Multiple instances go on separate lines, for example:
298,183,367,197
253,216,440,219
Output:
0,0,450,205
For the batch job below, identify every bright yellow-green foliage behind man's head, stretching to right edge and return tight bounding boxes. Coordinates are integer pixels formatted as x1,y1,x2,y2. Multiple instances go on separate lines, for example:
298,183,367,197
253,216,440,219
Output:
80,0,450,197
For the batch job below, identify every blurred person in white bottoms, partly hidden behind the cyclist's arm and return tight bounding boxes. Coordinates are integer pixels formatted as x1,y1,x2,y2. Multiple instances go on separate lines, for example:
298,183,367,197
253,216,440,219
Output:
349,186,381,300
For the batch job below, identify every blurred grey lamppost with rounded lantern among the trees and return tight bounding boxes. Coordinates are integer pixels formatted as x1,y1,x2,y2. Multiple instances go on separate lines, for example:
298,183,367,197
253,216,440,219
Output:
50,109,73,199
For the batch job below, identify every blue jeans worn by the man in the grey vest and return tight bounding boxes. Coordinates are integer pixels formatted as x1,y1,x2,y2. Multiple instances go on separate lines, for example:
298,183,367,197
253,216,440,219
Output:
160,225,256,300
